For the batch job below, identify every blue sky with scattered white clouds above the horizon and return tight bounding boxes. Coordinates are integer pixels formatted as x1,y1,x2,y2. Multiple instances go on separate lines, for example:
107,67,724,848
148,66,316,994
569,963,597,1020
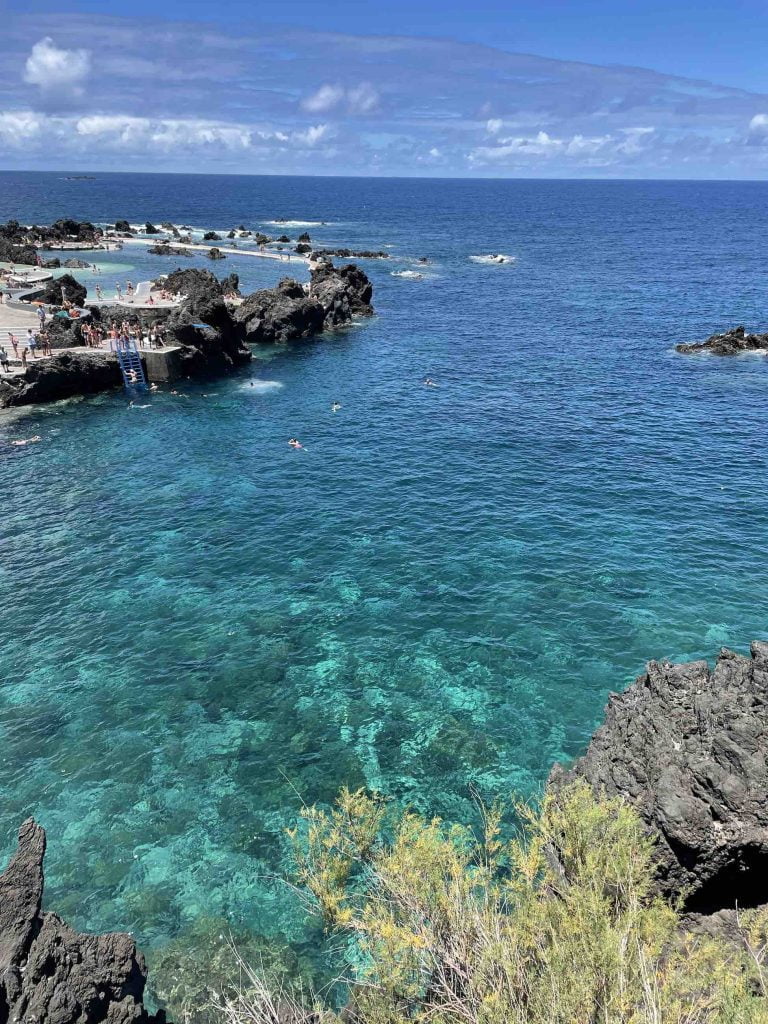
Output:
0,0,768,178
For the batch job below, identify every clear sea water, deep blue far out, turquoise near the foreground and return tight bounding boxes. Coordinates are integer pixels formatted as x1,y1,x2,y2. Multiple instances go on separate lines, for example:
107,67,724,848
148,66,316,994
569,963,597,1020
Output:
0,173,768,983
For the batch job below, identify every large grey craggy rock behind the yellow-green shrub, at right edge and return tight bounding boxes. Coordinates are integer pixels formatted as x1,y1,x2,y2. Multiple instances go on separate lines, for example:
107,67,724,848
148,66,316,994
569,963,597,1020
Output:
553,643,768,914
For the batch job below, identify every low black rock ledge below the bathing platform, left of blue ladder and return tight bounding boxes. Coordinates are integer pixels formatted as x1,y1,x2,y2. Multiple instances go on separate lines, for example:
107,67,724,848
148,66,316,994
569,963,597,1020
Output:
0,348,121,409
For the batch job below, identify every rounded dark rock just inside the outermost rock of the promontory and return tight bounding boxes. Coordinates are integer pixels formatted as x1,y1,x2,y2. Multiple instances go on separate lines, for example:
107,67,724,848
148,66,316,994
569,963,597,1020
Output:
233,278,325,344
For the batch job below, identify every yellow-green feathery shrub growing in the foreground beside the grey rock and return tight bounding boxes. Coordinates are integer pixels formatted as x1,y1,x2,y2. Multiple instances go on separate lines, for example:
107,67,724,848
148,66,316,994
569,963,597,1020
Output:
159,783,768,1024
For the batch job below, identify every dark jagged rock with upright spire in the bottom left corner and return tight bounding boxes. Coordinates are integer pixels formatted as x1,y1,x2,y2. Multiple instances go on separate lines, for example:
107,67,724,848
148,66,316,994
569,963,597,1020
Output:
0,818,164,1024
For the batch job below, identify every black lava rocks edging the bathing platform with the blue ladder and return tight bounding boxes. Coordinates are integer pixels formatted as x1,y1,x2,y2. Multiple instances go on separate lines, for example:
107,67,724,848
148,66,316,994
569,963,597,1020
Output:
0,260,374,409
